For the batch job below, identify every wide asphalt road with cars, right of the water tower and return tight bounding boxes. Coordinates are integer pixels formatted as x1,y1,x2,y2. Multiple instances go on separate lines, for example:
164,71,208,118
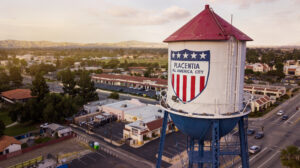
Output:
235,94,300,168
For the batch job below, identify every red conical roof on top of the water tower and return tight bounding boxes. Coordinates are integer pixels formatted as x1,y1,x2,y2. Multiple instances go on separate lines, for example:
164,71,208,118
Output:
164,5,252,42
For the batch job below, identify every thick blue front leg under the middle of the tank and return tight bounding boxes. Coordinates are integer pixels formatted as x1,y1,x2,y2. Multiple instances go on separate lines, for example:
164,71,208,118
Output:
212,120,220,168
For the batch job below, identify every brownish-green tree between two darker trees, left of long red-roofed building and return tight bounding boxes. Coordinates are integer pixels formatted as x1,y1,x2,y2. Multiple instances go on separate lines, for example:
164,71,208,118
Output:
61,68,77,97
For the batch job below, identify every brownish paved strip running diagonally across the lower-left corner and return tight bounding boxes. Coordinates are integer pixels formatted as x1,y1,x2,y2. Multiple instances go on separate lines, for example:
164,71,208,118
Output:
0,138,86,168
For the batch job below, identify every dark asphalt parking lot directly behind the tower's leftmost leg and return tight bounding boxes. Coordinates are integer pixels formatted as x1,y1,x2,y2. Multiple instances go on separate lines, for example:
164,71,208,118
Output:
121,132,186,167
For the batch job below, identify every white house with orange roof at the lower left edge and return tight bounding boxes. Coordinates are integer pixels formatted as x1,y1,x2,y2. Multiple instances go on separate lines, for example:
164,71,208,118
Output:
0,135,21,156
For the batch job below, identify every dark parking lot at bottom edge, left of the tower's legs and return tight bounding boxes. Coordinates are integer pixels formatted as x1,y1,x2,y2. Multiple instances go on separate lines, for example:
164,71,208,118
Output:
68,150,134,168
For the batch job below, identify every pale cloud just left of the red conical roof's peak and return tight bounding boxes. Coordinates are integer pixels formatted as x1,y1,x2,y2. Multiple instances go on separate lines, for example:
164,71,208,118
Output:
107,6,190,25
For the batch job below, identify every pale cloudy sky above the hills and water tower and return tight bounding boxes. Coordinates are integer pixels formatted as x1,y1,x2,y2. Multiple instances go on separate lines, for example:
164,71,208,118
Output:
0,0,300,46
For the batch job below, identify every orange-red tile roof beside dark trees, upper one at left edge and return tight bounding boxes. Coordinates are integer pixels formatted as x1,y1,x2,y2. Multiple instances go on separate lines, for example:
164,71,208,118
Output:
1,89,33,100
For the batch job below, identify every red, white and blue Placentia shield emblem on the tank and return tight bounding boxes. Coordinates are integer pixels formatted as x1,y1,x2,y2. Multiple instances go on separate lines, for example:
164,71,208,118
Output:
170,49,210,103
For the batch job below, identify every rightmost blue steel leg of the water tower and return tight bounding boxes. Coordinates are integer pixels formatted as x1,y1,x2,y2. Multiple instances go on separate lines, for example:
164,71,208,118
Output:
239,117,249,168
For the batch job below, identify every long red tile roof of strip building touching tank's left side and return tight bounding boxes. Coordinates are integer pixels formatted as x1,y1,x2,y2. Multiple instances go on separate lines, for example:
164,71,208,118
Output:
93,74,168,85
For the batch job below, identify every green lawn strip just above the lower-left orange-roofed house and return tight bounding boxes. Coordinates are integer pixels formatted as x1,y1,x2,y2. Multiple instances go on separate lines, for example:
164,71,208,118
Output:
4,122,38,136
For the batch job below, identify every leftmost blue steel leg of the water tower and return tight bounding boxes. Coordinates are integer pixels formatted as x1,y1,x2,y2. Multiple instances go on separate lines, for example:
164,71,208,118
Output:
156,111,169,168
